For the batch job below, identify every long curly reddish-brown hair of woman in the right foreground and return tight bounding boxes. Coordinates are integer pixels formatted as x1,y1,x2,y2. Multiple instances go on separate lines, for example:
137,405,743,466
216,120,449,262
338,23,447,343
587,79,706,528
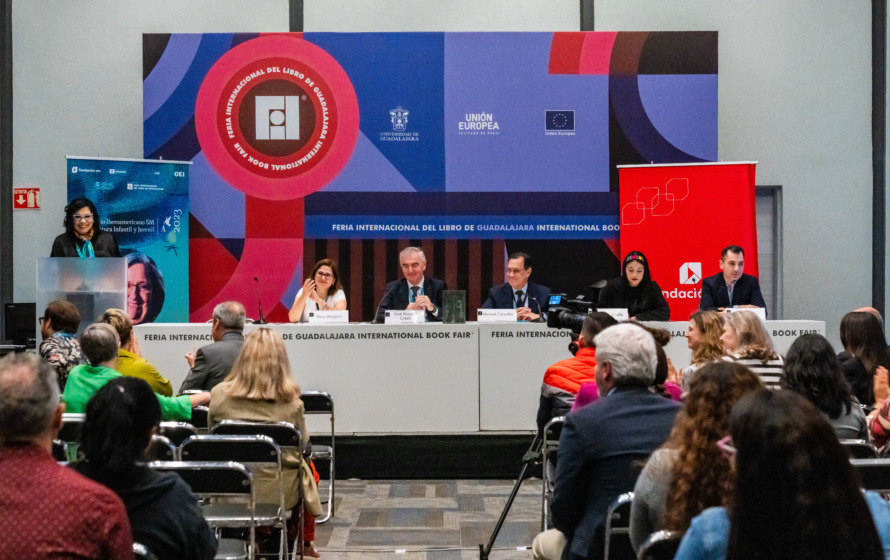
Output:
664,361,763,530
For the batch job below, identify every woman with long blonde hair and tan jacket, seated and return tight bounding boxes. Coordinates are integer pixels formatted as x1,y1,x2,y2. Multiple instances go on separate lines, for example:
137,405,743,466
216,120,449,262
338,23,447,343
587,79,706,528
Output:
210,328,323,557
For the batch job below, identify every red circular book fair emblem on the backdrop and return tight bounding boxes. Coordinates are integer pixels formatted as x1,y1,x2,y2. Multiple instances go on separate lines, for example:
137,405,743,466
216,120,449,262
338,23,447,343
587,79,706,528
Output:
195,35,359,200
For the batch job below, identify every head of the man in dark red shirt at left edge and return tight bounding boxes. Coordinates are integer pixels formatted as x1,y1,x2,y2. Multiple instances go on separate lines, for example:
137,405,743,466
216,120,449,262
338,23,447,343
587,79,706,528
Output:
0,353,61,445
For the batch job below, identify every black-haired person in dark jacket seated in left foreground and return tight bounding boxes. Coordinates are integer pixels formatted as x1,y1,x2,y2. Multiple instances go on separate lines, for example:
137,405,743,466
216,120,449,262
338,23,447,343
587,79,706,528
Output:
75,377,216,560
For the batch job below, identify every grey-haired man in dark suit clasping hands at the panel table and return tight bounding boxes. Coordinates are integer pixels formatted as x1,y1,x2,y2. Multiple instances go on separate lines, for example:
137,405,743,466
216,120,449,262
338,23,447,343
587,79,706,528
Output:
374,247,446,323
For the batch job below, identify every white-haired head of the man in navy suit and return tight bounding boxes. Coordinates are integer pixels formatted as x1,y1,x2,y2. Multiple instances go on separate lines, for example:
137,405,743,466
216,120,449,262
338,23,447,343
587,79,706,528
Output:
594,323,658,387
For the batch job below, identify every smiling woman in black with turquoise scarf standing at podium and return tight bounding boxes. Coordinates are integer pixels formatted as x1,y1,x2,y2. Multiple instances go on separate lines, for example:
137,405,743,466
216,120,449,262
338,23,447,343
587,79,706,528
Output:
49,197,121,259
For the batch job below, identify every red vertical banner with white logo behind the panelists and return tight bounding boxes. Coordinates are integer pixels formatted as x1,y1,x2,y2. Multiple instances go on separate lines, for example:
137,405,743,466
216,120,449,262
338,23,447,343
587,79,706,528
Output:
618,162,757,321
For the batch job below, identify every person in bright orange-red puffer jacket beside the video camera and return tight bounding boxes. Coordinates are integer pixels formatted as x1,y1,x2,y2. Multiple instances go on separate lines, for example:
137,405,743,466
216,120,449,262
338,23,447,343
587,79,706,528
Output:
537,312,618,432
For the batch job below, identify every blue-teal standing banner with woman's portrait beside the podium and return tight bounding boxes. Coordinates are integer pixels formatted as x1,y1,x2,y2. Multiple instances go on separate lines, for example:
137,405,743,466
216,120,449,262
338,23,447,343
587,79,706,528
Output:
67,156,190,325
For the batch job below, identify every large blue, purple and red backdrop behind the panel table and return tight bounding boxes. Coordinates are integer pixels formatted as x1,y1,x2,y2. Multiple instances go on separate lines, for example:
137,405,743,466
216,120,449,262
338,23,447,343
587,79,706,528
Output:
143,32,717,321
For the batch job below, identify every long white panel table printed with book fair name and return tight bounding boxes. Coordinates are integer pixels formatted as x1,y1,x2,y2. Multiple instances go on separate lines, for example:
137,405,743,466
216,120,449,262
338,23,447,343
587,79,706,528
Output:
135,321,825,433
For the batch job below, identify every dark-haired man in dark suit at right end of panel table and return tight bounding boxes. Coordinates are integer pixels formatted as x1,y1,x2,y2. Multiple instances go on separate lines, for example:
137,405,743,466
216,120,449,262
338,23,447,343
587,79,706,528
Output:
698,245,766,311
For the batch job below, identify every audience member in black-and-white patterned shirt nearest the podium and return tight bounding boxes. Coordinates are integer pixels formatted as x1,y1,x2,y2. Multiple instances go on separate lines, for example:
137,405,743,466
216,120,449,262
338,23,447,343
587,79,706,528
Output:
40,300,86,390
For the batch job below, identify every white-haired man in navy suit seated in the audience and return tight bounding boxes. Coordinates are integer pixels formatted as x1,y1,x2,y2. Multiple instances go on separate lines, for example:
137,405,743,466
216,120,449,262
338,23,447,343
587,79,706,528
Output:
532,323,680,560
